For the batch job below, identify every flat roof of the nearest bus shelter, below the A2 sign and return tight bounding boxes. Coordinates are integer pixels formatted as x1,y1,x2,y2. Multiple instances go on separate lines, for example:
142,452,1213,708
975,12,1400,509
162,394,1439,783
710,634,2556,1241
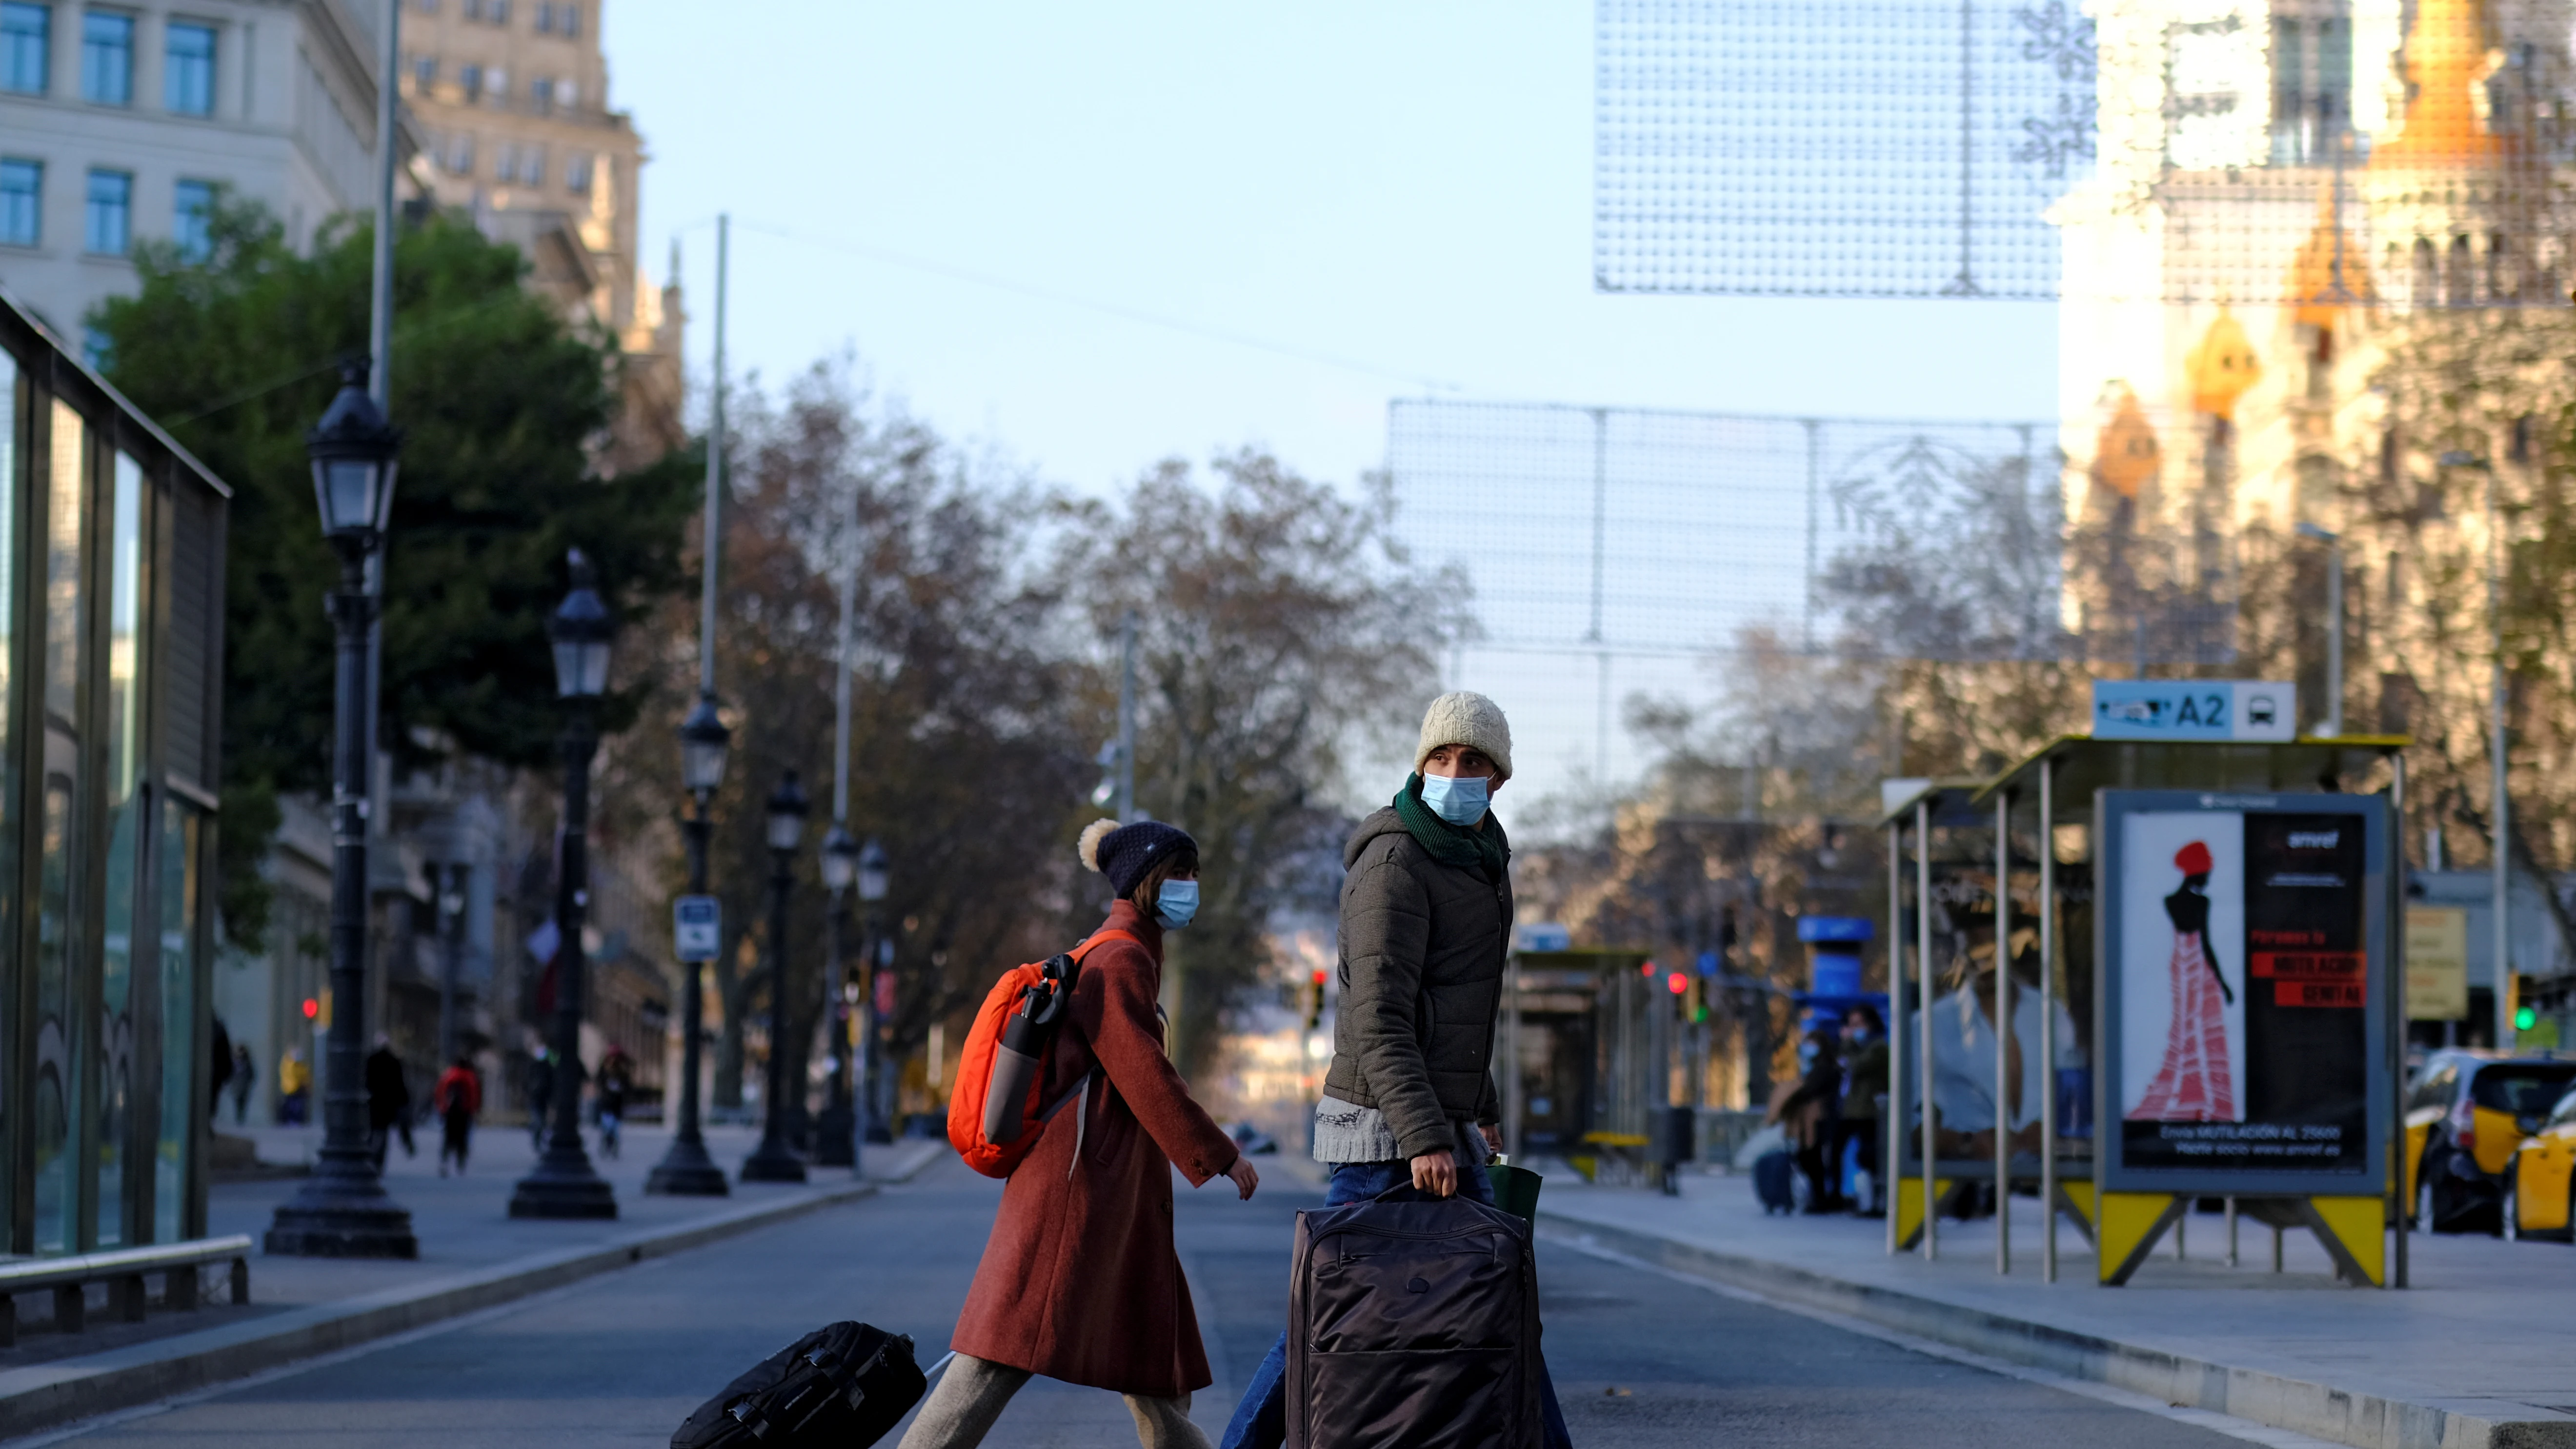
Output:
1976,735,2414,804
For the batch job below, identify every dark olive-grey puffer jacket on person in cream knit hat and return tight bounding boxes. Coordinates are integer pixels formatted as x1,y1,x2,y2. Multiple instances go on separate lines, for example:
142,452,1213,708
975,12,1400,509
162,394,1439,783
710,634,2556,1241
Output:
1324,807,1512,1158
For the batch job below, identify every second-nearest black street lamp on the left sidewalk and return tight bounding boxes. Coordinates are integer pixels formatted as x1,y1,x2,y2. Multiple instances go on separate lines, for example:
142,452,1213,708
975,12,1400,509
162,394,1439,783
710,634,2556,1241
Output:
510,549,618,1217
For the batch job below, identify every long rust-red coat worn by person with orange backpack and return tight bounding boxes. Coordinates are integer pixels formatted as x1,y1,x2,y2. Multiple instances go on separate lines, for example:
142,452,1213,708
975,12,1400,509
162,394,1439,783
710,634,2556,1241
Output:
950,900,1236,1397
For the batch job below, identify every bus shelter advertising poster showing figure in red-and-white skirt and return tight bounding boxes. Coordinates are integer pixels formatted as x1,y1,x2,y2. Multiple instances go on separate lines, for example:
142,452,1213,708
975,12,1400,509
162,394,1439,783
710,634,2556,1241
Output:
2094,791,2391,1194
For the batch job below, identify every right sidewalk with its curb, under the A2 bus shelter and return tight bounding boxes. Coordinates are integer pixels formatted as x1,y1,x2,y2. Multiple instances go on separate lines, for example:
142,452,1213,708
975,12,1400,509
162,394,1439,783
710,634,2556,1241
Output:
1540,1168,2576,1449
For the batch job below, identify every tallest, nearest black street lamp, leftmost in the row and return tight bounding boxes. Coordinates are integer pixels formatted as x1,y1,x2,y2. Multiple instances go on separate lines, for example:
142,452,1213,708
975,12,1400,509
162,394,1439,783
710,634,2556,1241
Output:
265,361,420,1258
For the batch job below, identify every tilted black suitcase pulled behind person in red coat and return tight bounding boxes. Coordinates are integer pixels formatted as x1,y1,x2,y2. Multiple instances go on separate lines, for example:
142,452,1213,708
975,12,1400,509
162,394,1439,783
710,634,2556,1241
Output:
670,1323,927,1449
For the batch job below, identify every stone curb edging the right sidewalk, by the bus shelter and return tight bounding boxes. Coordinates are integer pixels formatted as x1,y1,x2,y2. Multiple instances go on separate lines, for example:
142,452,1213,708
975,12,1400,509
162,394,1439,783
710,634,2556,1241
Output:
1538,1209,2576,1449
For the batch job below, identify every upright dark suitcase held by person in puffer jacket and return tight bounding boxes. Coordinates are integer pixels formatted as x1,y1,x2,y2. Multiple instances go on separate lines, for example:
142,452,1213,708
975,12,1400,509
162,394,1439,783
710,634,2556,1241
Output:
1286,1186,1540,1449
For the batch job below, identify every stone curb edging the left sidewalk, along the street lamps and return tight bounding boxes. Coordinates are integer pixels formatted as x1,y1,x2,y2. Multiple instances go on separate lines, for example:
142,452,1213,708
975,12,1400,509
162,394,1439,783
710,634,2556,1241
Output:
0,1175,891,1439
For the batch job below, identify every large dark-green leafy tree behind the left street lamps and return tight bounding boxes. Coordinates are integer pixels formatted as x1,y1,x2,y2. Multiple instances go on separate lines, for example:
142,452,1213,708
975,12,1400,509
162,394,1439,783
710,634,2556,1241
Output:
90,201,701,944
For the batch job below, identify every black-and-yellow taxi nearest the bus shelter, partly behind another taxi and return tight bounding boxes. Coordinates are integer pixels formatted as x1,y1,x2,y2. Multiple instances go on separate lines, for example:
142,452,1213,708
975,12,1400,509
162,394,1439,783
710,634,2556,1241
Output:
2406,1052,2576,1232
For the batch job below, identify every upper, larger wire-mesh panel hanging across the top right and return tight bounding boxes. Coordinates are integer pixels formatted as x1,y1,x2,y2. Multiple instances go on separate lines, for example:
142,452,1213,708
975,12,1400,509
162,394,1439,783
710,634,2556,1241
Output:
1592,0,2576,304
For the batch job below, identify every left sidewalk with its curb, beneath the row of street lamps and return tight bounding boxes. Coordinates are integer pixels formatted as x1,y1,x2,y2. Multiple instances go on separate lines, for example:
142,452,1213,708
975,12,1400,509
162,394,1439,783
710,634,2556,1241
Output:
0,1124,948,1439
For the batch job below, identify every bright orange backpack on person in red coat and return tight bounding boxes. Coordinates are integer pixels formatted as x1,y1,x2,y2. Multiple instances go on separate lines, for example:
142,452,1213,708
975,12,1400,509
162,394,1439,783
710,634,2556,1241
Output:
948,931,1144,1178
